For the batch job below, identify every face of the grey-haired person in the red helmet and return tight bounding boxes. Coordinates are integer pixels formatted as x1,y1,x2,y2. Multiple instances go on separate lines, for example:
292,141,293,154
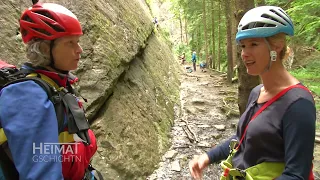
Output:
52,36,82,71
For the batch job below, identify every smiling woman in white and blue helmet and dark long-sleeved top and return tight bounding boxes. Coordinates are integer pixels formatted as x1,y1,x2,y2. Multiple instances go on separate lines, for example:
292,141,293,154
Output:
189,6,316,180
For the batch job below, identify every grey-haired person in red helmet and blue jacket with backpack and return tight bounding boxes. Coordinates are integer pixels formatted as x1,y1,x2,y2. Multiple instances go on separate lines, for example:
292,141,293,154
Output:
0,0,101,180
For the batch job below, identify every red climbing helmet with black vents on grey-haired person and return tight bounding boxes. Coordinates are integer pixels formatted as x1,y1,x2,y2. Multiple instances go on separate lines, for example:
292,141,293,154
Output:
20,3,83,43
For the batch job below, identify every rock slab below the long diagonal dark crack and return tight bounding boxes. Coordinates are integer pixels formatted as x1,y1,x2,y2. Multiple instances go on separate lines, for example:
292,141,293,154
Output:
93,36,179,179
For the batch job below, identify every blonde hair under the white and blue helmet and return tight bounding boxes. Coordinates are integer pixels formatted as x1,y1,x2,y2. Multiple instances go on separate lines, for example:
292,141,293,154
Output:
267,33,290,62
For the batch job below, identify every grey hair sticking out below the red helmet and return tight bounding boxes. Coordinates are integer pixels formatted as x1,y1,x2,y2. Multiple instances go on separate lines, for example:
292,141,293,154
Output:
26,39,50,66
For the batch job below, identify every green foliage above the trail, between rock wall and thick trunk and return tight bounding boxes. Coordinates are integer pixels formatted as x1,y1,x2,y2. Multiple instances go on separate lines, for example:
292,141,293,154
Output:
171,0,226,70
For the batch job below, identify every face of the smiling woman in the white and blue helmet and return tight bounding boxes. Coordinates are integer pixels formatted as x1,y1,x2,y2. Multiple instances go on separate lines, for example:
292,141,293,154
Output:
240,38,270,75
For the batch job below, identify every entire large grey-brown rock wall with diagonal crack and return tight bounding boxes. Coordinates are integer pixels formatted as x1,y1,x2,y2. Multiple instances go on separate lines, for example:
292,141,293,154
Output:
0,0,179,179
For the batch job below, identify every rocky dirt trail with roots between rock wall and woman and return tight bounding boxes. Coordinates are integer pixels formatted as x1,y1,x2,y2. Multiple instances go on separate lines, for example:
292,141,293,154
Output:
148,64,238,180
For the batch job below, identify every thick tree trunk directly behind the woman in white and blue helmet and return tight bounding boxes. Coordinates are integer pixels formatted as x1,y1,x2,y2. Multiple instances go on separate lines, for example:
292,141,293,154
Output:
236,0,260,114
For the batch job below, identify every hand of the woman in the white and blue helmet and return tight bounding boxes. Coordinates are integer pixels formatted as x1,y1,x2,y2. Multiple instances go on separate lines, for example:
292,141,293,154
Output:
189,153,209,179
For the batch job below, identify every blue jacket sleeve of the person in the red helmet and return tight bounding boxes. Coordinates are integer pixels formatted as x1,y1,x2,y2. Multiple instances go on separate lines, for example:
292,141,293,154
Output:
0,81,63,179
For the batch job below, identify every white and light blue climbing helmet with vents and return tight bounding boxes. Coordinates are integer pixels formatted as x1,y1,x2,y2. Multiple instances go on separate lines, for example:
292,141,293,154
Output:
236,6,294,43
